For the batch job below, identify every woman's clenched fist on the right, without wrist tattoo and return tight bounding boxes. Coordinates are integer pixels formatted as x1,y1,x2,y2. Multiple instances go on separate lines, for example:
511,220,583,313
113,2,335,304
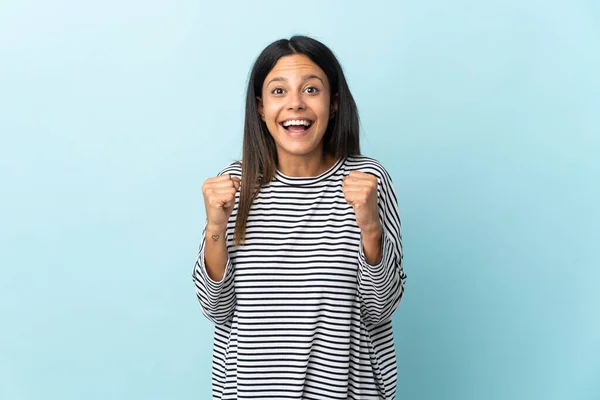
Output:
342,171,381,233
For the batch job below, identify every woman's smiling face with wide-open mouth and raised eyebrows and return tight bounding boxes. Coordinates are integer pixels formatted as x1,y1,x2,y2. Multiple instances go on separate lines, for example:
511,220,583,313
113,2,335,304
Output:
258,54,337,162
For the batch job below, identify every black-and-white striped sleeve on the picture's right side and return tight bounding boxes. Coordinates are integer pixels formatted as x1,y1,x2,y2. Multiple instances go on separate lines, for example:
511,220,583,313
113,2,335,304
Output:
358,169,406,325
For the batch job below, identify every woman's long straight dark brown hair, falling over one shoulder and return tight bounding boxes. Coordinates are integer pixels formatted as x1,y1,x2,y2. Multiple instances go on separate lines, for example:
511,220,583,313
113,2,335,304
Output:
234,36,360,246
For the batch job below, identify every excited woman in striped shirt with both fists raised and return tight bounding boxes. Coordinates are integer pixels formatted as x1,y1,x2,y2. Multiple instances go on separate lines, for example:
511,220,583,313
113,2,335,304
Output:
193,36,406,399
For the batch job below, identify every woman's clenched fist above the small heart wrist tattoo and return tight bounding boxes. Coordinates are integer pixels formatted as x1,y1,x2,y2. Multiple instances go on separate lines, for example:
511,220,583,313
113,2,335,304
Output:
202,174,240,230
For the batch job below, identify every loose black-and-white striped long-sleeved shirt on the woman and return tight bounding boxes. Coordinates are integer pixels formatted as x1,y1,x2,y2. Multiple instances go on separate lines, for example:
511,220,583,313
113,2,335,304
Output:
192,156,406,400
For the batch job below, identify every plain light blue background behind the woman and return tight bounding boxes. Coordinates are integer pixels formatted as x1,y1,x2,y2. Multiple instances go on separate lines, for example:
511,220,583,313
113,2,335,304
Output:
0,0,600,400
